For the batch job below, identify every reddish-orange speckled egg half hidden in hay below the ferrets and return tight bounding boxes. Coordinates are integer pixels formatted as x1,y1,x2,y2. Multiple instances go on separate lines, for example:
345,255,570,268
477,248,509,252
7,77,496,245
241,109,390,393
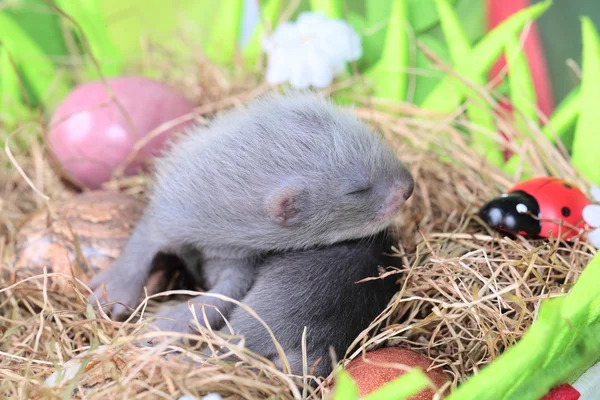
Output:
346,347,448,400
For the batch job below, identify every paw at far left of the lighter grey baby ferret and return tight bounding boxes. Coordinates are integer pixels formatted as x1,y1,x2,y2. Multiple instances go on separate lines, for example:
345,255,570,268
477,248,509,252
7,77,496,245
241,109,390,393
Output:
88,268,143,319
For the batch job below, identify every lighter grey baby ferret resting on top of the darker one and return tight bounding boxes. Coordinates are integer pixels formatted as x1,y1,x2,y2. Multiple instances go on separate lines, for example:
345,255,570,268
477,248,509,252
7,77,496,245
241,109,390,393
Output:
89,93,414,331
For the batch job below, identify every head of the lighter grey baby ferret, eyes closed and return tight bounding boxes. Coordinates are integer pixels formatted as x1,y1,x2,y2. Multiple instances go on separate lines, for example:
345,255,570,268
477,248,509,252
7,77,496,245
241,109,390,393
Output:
250,94,414,248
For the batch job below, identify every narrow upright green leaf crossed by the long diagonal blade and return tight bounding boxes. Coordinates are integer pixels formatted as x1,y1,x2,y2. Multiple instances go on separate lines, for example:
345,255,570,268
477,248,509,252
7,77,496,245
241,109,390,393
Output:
435,0,504,165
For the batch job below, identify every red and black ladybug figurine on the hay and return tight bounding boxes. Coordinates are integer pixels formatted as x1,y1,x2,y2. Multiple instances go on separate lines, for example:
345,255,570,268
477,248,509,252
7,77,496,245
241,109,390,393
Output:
479,177,591,240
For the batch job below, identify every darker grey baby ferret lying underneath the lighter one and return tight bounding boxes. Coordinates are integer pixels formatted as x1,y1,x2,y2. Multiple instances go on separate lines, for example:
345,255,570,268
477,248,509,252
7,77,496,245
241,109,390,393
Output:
213,231,401,377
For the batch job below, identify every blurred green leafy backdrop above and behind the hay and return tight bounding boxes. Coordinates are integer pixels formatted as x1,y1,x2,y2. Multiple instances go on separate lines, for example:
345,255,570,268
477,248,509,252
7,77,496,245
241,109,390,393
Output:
0,0,600,184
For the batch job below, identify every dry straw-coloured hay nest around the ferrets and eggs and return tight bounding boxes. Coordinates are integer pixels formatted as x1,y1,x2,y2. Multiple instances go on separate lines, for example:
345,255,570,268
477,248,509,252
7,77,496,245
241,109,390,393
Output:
0,52,594,399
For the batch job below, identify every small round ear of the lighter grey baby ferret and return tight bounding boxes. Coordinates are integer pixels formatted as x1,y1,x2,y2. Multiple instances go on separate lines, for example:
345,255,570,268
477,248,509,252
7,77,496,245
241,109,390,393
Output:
267,180,306,226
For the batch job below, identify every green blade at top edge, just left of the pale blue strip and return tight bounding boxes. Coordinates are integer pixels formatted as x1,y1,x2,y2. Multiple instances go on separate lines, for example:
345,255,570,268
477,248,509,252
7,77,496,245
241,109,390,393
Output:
204,0,244,64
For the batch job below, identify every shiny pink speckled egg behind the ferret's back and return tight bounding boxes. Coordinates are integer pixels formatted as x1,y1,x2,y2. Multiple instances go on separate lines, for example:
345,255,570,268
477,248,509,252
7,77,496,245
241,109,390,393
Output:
47,76,193,189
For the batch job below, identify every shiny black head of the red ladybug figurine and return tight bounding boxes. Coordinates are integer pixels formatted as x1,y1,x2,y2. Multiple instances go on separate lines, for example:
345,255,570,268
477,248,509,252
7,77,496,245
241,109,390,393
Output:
479,190,542,236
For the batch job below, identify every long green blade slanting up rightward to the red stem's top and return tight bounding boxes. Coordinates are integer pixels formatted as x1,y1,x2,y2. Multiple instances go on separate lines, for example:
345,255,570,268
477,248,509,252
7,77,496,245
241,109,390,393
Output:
421,0,552,113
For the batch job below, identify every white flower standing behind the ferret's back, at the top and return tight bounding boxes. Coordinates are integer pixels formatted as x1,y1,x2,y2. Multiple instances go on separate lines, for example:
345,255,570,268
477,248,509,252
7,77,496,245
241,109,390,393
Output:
262,12,362,89
